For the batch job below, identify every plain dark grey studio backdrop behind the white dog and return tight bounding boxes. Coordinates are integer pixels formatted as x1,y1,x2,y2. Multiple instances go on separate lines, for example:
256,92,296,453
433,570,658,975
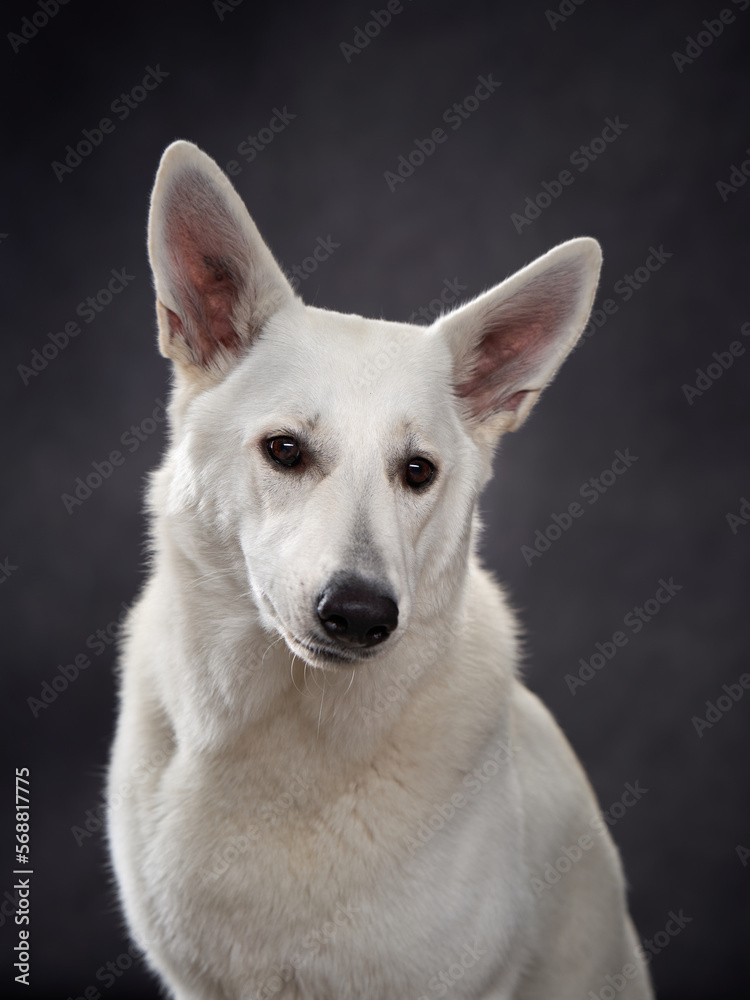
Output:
0,0,750,1000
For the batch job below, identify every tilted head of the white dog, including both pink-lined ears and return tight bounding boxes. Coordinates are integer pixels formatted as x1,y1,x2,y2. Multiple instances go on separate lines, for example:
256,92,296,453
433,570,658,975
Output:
149,142,601,667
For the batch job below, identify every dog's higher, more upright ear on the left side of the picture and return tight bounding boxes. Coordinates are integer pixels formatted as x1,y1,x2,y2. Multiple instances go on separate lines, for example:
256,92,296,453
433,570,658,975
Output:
148,141,295,375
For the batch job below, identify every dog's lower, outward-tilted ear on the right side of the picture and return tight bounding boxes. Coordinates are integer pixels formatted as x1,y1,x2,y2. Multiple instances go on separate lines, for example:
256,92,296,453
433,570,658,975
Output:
434,237,602,433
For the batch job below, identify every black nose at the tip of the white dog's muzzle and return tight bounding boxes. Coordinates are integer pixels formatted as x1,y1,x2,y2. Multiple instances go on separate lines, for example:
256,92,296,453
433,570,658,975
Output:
318,579,398,647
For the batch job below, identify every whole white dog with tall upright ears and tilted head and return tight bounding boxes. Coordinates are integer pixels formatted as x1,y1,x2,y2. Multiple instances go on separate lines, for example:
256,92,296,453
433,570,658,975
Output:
108,142,652,1000
